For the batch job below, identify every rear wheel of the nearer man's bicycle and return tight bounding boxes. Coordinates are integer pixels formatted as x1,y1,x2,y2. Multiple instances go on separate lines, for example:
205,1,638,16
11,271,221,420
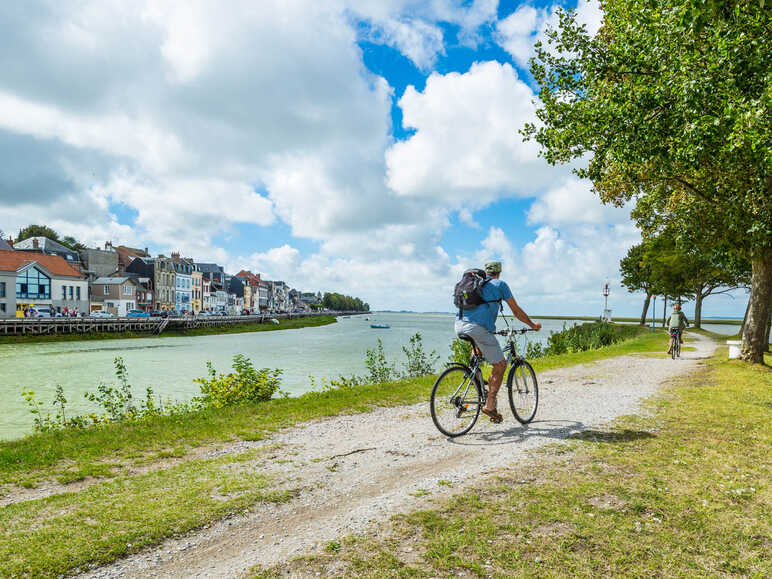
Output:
430,366,482,437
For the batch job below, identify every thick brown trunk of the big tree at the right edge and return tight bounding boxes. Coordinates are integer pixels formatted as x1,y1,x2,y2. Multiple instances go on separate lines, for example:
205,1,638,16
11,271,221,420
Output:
742,248,772,364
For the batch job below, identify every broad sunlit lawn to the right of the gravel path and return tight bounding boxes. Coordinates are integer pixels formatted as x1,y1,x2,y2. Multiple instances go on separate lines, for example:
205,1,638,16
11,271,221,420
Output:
258,348,772,577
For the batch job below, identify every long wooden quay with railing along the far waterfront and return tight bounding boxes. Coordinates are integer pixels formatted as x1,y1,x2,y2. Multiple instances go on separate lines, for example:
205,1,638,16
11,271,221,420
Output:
0,311,367,336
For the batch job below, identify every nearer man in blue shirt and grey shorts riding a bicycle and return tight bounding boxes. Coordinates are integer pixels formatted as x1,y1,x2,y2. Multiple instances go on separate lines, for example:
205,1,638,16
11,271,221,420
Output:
455,261,541,422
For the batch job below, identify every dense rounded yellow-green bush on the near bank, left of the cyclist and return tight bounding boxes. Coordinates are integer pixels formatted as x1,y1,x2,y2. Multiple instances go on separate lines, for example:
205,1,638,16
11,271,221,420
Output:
194,354,282,408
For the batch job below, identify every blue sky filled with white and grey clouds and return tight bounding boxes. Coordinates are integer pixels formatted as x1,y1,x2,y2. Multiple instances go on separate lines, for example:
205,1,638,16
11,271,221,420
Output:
0,0,745,316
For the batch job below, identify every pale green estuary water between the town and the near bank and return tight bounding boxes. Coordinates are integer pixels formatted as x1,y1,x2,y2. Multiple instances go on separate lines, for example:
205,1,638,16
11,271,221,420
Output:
0,313,737,439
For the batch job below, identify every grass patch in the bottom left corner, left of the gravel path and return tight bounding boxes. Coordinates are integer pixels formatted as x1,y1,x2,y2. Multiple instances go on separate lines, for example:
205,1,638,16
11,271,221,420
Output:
0,453,292,577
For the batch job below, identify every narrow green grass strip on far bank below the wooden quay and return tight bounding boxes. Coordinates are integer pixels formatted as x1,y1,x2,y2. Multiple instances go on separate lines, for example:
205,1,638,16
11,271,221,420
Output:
0,316,336,344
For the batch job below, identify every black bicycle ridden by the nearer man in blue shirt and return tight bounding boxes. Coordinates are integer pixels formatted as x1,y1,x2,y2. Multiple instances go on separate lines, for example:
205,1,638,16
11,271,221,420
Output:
430,328,539,438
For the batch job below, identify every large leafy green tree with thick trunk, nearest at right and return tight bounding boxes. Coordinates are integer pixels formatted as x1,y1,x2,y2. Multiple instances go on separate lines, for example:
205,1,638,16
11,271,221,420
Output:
524,0,772,363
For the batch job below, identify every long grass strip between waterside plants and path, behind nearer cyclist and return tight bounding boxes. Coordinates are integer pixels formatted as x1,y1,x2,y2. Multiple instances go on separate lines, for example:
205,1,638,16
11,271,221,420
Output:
0,331,667,486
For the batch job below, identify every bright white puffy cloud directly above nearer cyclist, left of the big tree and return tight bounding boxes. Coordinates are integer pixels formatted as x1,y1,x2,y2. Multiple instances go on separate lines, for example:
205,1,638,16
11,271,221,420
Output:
386,61,561,206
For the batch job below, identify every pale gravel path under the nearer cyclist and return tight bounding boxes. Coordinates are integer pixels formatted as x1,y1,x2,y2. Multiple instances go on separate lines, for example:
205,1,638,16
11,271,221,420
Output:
81,334,715,577
